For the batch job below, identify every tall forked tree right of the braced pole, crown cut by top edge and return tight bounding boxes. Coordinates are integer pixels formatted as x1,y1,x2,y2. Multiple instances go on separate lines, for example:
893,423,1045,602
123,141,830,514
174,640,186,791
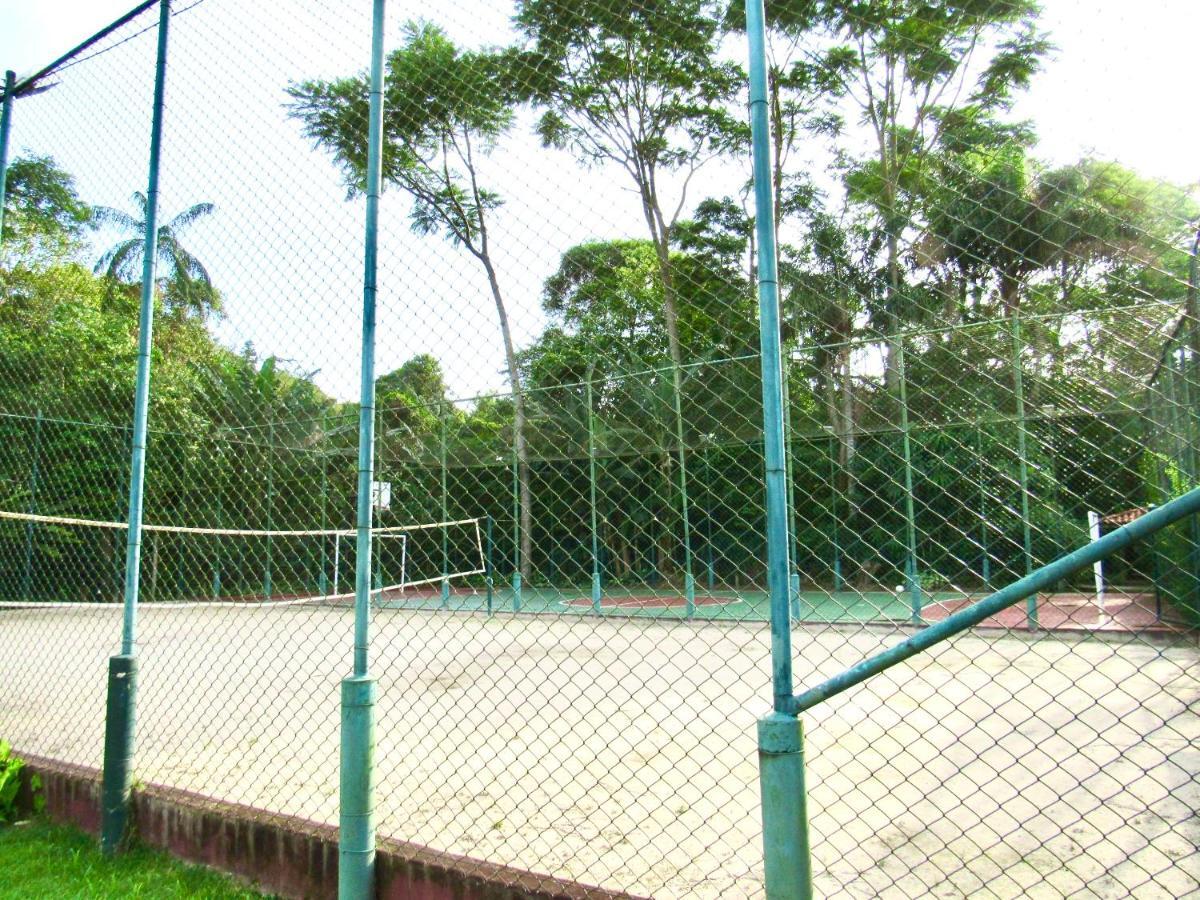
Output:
796,0,1050,389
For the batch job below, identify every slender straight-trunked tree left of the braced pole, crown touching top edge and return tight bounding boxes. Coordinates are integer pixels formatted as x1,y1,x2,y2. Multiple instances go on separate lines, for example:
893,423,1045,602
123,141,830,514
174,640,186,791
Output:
516,0,746,585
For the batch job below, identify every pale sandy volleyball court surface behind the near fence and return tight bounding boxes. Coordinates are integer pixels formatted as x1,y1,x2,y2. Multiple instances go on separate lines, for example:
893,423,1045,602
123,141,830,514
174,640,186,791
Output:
0,605,1200,898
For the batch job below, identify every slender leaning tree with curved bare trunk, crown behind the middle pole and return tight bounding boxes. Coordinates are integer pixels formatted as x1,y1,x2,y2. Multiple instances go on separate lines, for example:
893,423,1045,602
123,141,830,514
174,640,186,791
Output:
289,23,533,580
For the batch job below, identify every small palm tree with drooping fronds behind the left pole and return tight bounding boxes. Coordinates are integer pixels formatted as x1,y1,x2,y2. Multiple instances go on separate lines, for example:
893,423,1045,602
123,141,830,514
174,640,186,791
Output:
92,192,220,318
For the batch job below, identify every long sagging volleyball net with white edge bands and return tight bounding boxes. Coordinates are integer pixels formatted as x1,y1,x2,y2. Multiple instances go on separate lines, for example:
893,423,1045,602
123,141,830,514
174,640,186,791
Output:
0,510,486,608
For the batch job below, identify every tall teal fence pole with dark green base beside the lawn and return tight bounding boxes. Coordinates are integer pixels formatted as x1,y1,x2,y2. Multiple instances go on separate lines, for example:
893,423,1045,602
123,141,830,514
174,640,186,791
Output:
100,0,170,854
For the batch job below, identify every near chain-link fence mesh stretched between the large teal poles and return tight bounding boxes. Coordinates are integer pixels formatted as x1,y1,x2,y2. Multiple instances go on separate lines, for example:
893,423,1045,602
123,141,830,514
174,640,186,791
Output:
0,0,1200,898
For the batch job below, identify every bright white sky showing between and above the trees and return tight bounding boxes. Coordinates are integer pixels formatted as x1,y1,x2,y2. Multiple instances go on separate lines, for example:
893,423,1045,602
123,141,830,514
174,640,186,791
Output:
0,0,1200,398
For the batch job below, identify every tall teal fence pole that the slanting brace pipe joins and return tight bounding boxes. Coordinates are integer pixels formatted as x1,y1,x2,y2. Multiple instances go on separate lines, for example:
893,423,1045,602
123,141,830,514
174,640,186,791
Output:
746,0,812,900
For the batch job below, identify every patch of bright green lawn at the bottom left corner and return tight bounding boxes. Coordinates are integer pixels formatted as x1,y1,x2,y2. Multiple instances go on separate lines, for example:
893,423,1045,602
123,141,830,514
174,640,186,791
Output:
0,820,262,900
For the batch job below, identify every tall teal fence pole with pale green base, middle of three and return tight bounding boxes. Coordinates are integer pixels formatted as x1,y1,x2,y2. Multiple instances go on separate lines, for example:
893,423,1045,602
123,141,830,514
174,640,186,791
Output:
337,0,385,900
